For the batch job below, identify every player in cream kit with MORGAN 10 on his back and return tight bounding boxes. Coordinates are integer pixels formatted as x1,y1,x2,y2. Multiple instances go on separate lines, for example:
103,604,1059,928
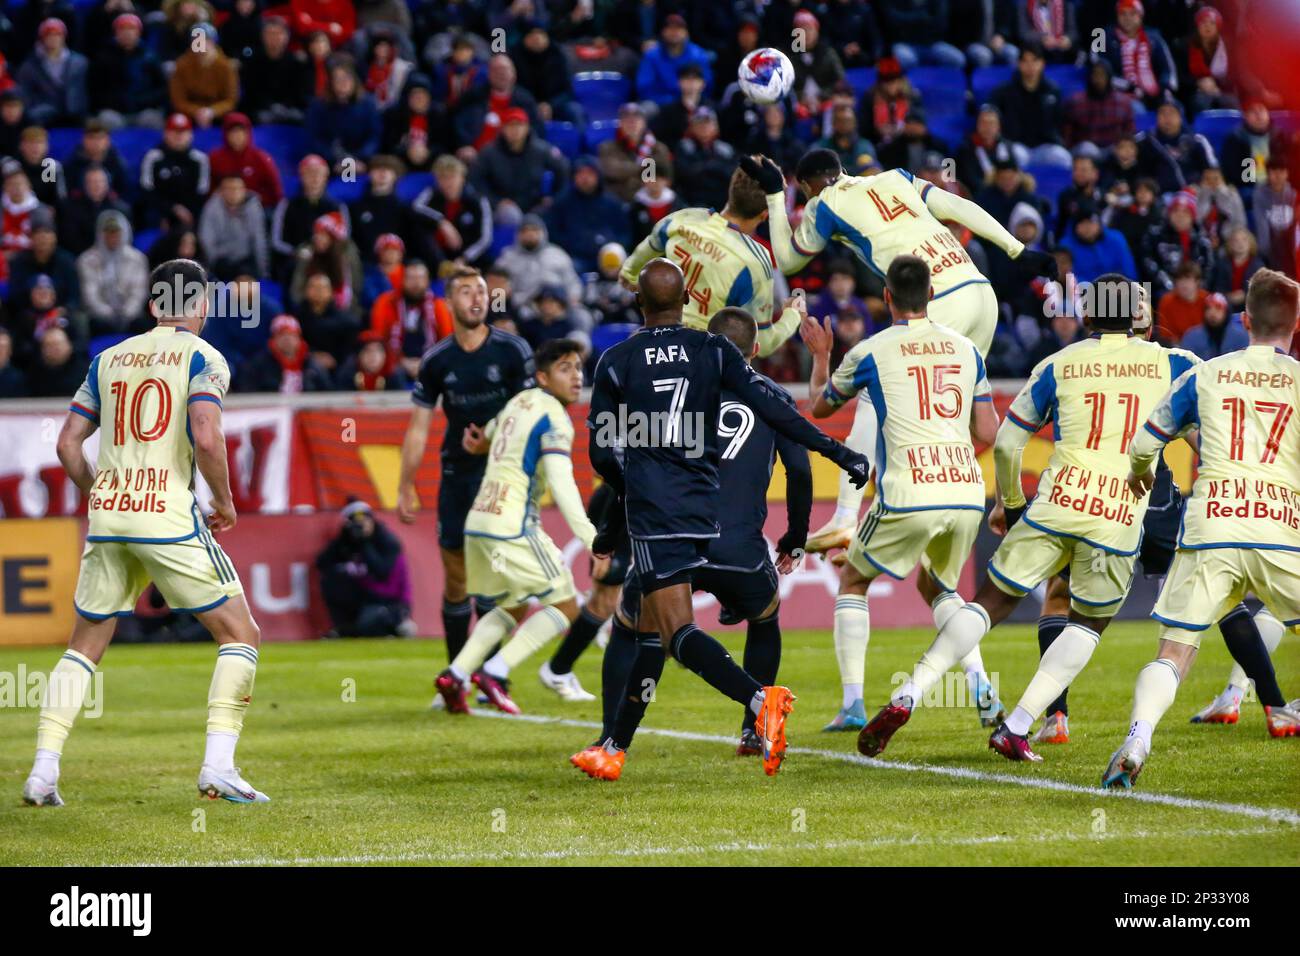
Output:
22,259,269,806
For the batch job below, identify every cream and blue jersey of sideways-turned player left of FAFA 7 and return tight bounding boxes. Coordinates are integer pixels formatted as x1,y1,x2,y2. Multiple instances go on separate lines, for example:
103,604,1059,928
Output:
465,388,573,538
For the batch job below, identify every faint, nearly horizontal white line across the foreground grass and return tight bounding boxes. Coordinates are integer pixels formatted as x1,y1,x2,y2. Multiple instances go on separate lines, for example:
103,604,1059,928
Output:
134,827,1277,866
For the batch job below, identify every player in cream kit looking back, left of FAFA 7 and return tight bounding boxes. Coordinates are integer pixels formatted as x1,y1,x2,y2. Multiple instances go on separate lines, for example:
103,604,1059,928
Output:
436,339,606,714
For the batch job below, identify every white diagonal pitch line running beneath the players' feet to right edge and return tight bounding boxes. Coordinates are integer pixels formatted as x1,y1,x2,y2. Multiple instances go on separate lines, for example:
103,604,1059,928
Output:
472,708,1300,825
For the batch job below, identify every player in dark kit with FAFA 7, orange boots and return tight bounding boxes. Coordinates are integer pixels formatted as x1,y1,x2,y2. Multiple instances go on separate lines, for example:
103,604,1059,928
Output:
577,259,867,775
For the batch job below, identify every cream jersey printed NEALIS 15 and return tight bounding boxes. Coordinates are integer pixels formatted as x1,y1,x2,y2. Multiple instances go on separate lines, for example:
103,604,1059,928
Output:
826,319,992,511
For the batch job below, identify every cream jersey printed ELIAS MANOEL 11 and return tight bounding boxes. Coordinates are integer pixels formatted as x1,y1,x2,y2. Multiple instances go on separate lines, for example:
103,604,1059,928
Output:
1008,333,1199,554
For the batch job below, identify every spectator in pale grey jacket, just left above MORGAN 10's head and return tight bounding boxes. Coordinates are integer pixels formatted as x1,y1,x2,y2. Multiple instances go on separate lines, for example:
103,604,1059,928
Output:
77,209,150,336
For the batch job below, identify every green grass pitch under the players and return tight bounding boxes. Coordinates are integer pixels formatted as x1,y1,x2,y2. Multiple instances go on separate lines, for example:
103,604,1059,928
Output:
0,623,1300,866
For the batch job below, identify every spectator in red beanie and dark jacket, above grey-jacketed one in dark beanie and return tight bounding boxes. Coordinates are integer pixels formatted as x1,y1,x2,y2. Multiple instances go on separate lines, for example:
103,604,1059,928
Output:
469,107,568,222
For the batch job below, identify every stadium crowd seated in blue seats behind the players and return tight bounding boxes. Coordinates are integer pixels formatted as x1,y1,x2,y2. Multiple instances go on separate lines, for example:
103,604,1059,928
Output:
0,0,1300,398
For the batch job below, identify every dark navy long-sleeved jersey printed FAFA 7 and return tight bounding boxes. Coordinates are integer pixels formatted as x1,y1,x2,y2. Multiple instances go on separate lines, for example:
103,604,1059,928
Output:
588,325,863,538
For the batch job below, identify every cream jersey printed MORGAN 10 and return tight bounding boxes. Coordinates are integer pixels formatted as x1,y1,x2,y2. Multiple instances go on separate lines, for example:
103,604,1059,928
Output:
72,326,230,542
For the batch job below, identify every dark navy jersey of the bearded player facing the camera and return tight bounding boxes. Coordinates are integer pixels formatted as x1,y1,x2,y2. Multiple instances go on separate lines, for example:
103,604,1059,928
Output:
411,326,533,466
